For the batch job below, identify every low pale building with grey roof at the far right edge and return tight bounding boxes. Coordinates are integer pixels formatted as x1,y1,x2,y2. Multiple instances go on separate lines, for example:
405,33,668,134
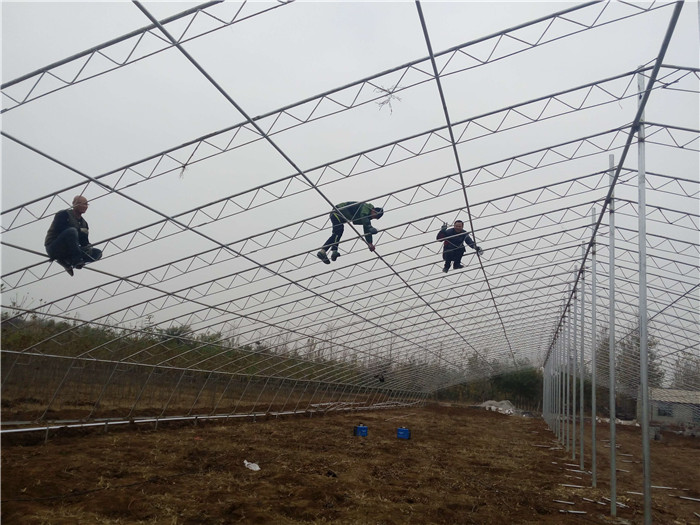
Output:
637,388,700,427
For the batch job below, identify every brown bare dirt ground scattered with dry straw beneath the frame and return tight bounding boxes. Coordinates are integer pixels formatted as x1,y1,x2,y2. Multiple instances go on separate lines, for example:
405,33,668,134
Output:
2,405,700,525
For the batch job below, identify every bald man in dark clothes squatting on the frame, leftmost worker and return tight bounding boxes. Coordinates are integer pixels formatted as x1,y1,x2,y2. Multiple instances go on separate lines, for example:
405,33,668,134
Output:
44,195,102,276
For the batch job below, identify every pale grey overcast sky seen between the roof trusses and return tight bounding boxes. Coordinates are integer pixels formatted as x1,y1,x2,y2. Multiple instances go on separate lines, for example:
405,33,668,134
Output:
2,1,700,370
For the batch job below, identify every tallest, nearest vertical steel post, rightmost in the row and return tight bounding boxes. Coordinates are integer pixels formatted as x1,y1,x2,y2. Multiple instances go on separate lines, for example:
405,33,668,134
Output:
637,72,651,525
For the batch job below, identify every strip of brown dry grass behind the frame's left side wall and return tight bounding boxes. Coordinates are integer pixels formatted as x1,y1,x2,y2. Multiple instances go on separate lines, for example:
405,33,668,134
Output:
0,355,400,423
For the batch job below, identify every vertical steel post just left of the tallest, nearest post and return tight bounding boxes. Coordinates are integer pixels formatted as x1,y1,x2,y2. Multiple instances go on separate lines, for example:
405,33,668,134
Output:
608,155,617,517
